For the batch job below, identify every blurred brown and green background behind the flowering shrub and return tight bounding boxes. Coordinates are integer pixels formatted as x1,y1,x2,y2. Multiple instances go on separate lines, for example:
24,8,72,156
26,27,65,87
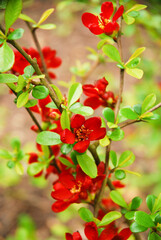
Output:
0,0,161,240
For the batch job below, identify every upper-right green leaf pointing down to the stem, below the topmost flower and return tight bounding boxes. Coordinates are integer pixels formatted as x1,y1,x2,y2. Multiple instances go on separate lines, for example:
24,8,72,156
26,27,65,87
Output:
102,45,123,65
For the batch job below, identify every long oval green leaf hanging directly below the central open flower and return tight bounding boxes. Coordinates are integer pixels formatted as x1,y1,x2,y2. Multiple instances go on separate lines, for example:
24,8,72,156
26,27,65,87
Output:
77,154,97,178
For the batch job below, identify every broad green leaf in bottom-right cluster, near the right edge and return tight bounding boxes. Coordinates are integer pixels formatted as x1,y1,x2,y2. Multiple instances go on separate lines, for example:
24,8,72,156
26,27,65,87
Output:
134,211,155,228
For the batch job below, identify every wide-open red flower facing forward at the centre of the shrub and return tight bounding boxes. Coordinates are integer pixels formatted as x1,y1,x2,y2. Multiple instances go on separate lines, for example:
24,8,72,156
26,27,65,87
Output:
60,114,106,153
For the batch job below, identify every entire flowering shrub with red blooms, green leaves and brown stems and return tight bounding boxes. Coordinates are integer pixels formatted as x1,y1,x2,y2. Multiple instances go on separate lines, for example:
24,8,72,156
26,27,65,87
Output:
0,0,161,240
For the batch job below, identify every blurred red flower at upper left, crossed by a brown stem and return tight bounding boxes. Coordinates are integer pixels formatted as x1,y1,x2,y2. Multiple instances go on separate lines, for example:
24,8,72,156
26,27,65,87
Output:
11,47,62,79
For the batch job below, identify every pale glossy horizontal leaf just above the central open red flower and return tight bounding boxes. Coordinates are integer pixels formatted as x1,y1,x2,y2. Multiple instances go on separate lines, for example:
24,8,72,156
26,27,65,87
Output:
69,102,94,116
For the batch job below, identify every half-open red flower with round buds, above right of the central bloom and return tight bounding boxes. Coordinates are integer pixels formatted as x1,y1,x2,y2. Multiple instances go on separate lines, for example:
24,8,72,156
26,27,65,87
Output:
83,77,116,110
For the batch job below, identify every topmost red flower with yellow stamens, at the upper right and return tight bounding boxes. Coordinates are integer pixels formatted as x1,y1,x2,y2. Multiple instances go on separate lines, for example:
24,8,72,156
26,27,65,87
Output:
82,2,124,35
